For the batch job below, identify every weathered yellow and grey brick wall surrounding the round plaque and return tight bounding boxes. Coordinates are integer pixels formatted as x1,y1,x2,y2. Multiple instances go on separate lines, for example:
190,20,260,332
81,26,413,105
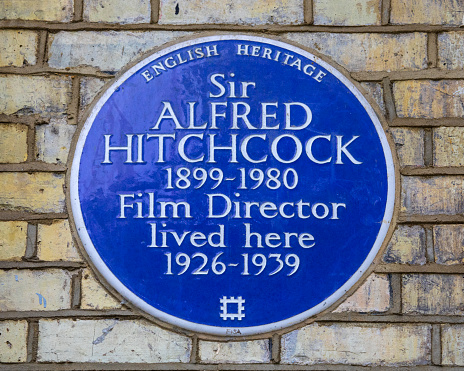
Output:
0,0,464,370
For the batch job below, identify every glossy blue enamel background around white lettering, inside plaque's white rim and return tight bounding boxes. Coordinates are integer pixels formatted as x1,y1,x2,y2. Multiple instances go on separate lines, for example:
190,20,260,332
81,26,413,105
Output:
78,40,387,327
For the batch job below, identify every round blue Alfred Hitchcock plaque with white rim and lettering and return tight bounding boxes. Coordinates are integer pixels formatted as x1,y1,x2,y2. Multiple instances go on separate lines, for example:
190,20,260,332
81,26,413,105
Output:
69,35,395,335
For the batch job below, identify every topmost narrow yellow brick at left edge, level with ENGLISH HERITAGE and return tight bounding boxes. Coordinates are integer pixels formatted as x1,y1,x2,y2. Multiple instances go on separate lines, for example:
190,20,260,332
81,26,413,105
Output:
0,30,38,67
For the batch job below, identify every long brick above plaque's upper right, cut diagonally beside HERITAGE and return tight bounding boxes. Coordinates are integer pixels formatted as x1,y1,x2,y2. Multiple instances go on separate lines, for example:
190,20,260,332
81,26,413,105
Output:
284,32,427,72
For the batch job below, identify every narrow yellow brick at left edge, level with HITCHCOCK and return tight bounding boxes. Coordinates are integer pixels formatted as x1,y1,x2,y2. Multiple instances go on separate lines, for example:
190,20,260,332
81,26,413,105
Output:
0,124,27,164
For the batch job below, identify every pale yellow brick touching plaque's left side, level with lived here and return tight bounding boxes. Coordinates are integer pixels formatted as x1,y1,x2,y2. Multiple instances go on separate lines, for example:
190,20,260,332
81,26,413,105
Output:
37,220,81,261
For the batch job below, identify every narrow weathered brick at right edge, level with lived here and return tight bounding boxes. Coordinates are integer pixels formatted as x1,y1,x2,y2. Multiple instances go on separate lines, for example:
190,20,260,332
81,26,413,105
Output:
433,224,464,265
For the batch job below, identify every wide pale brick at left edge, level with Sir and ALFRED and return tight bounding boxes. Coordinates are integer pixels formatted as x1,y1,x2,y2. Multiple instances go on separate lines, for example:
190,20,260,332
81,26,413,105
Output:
0,75,71,118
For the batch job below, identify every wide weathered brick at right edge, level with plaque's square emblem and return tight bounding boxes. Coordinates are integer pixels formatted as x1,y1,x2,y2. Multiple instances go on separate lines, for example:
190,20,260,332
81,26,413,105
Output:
402,274,464,315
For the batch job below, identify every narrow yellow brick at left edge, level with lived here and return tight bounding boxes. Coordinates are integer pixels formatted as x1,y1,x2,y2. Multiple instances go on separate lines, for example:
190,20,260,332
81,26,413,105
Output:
0,222,27,261
